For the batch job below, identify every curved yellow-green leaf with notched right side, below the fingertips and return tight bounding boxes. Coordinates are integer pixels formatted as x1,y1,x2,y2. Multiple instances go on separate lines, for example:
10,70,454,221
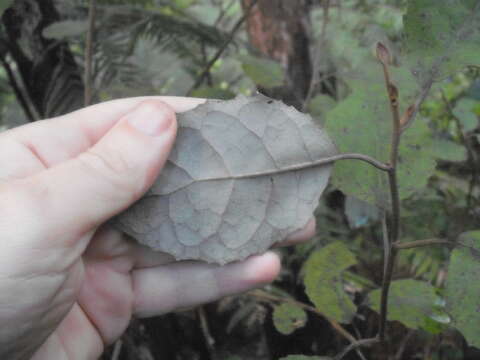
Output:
304,242,356,323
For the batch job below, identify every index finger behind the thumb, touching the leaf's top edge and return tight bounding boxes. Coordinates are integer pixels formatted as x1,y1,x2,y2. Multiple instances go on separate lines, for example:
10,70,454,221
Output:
0,97,205,180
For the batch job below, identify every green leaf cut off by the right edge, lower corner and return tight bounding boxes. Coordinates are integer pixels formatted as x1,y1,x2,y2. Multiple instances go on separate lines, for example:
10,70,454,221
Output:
445,230,480,347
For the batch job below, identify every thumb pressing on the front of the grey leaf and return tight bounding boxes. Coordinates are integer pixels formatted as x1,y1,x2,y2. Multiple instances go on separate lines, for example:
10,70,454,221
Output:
15,100,177,236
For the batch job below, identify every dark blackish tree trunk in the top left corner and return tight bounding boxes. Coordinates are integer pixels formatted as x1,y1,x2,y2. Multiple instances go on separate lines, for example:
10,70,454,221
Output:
2,0,83,120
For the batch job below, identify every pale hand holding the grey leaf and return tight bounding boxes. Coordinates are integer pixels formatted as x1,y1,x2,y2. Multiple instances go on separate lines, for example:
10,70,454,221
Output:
0,97,315,360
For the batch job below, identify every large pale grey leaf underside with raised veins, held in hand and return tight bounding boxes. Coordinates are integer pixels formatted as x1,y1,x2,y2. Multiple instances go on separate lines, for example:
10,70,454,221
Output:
116,95,336,263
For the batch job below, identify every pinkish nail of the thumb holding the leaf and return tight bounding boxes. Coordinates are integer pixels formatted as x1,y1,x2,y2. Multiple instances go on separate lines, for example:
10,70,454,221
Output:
127,101,174,136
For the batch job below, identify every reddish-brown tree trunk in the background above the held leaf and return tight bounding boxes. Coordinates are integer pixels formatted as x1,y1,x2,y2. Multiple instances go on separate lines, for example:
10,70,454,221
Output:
242,0,313,109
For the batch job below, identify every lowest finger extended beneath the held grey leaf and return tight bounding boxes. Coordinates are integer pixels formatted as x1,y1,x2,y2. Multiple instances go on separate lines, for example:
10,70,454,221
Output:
132,252,280,317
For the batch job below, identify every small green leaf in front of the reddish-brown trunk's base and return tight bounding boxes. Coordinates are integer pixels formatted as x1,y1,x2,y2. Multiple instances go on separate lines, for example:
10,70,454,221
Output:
239,55,284,88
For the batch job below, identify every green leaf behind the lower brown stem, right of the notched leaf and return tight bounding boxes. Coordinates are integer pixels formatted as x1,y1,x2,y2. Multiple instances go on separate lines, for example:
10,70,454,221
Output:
367,279,437,329
